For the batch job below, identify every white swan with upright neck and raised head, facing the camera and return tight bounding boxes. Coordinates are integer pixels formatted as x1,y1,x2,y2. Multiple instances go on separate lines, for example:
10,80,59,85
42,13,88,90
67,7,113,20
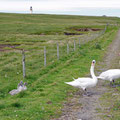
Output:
65,60,98,95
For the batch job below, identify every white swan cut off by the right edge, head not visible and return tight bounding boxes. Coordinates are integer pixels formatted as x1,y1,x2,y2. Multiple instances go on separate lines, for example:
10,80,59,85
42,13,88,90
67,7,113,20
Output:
97,69,120,85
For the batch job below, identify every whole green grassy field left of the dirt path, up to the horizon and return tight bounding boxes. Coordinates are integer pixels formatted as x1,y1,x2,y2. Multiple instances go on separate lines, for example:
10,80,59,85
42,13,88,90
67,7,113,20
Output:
0,14,119,120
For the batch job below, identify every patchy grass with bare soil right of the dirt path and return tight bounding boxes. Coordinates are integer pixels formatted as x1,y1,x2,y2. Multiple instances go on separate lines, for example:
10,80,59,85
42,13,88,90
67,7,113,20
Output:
99,64,120,120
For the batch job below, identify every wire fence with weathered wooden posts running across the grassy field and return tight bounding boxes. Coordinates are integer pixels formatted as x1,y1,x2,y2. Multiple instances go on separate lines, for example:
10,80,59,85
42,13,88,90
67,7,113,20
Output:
0,27,106,79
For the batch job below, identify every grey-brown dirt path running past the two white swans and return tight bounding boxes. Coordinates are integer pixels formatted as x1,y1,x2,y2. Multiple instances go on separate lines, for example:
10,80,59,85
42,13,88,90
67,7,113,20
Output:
55,30,120,120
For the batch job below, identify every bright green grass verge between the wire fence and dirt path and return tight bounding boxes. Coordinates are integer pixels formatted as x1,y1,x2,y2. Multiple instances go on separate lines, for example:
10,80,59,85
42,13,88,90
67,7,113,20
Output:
1,26,116,120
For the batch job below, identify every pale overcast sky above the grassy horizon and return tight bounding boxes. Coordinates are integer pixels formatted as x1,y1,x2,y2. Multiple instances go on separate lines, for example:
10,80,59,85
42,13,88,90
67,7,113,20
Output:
0,0,120,16
